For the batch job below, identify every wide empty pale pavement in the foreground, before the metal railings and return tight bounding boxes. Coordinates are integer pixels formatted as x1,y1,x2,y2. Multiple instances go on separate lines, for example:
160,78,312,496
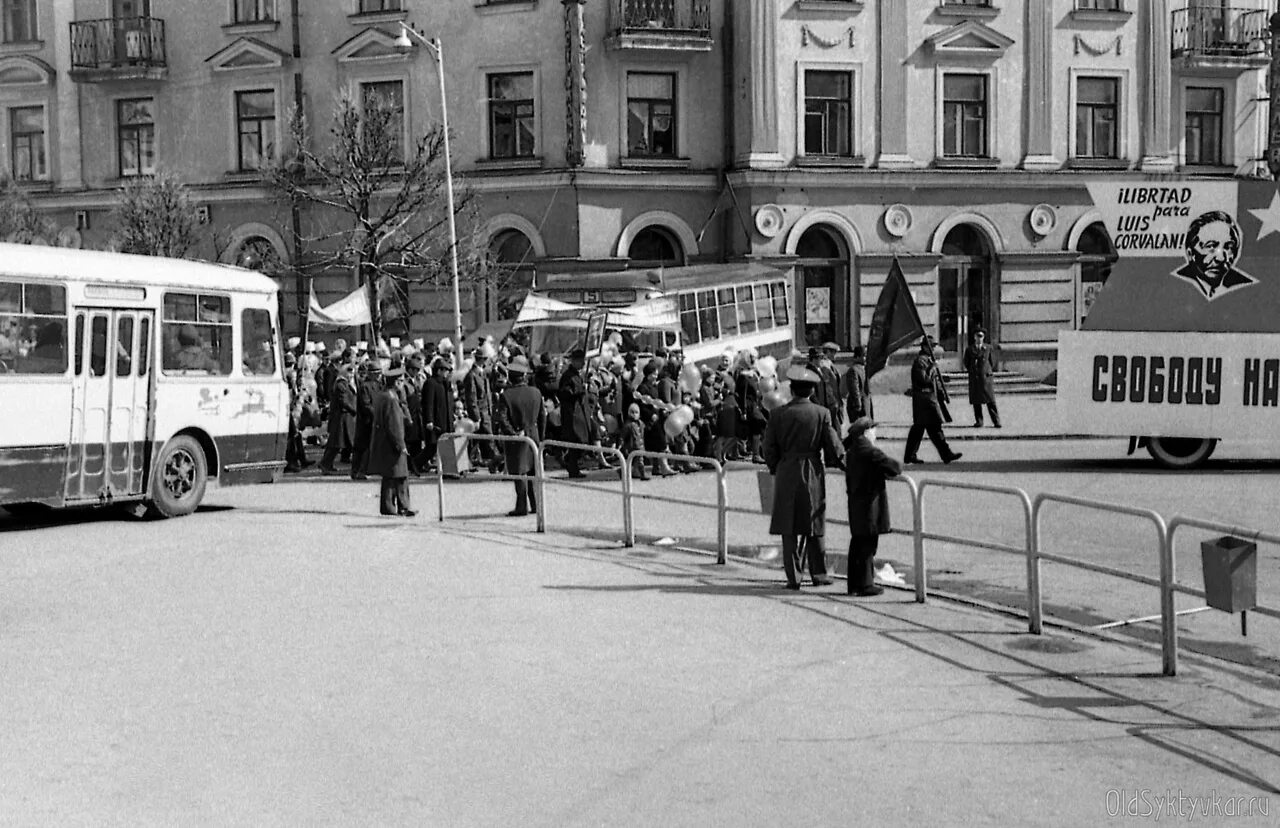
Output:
0,476,1280,827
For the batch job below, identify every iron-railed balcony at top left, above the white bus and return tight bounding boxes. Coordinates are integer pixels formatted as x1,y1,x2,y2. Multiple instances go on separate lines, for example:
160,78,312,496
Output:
70,17,169,83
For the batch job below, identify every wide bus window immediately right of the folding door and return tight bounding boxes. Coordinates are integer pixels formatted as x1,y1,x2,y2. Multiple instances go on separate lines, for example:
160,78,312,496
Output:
161,293,232,376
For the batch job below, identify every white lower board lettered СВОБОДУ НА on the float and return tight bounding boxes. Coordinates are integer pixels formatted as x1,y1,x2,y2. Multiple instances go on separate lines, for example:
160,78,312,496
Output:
1057,330,1280,440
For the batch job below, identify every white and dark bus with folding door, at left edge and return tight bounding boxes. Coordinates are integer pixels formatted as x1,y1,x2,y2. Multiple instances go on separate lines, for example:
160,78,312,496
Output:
0,244,288,517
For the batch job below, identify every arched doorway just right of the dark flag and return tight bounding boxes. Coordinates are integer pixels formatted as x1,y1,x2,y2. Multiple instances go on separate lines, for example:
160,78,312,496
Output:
938,224,1000,353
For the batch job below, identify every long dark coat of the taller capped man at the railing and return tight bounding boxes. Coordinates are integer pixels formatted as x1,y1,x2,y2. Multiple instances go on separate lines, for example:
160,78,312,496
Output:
762,399,844,536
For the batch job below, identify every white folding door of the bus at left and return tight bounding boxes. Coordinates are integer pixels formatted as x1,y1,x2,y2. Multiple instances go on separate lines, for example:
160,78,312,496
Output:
67,308,154,500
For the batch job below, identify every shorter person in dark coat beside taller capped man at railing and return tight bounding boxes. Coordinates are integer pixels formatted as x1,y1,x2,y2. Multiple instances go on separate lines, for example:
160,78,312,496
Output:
845,417,902,598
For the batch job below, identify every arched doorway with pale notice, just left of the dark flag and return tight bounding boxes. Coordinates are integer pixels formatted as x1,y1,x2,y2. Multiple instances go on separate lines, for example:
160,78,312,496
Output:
796,225,852,349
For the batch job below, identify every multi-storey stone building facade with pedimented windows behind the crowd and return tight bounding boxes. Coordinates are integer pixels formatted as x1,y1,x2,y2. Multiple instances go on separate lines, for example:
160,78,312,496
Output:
0,0,1270,367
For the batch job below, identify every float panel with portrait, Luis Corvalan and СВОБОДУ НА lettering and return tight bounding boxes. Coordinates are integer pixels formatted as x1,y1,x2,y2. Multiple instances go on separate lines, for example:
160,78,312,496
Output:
1057,182,1280,440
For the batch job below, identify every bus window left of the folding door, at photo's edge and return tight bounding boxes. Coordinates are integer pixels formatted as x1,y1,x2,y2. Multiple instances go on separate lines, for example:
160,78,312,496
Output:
0,282,67,376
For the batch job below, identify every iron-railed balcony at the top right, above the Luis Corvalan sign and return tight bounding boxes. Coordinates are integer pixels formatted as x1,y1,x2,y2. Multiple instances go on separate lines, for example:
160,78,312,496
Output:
1172,5,1271,70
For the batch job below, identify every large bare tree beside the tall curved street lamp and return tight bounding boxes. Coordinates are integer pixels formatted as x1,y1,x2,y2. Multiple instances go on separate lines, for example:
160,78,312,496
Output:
266,93,484,340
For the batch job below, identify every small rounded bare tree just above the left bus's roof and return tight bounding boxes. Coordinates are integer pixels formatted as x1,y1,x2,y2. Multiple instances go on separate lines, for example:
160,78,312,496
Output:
110,173,202,259
